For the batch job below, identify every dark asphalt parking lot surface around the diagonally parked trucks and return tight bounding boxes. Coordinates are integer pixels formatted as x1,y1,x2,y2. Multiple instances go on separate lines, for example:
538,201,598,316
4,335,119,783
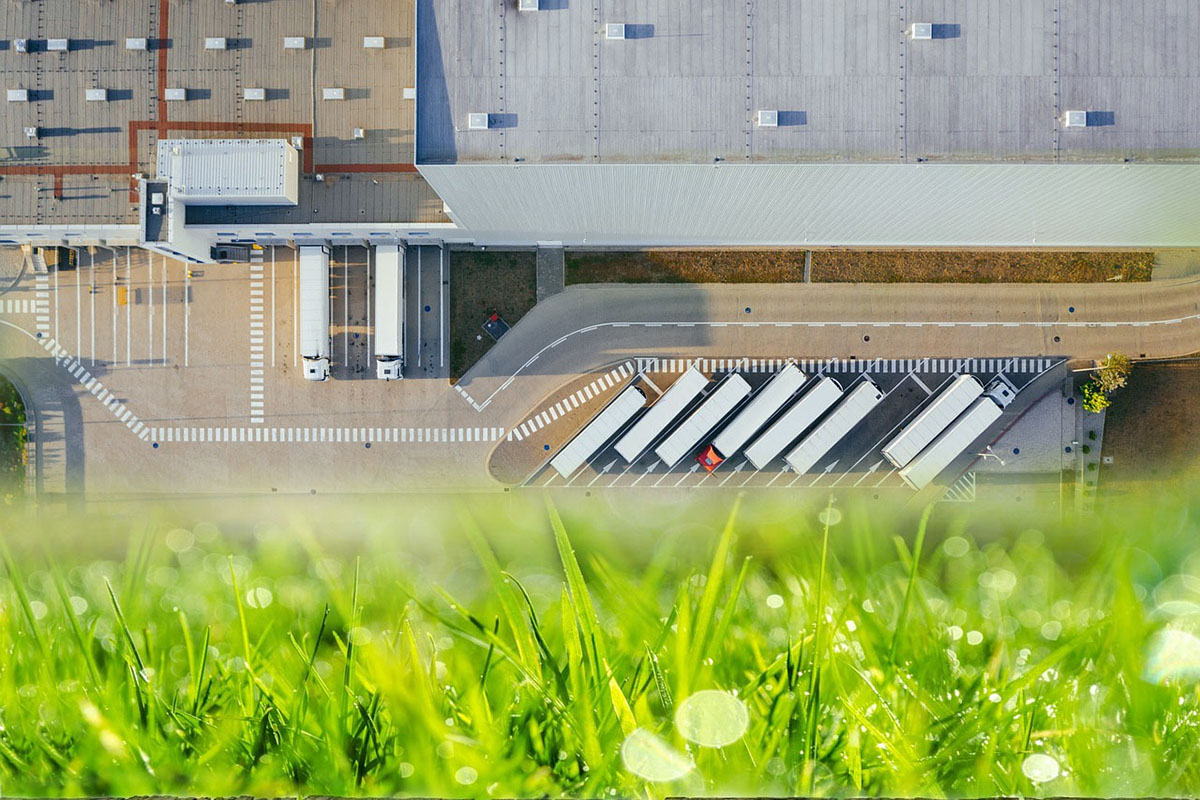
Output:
517,356,1063,489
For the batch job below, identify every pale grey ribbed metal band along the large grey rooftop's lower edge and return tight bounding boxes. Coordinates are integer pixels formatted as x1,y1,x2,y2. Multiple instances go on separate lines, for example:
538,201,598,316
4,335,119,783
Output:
421,163,1200,247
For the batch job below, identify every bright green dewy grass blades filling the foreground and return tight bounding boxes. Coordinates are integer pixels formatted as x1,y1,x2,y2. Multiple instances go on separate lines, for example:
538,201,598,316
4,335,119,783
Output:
0,493,1200,798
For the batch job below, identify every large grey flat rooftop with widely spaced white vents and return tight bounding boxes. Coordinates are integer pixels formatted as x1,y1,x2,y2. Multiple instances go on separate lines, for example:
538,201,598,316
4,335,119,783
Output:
416,0,1200,164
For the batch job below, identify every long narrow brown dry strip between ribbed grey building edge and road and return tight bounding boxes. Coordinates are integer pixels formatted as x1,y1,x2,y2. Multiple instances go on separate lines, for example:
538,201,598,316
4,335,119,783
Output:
566,249,1154,284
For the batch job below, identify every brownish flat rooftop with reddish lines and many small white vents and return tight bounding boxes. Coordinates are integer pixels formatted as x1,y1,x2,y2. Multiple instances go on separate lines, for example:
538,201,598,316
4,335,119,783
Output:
0,0,446,224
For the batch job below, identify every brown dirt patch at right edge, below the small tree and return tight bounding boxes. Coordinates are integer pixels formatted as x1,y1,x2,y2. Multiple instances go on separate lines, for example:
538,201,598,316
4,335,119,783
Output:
1100,360,1200,485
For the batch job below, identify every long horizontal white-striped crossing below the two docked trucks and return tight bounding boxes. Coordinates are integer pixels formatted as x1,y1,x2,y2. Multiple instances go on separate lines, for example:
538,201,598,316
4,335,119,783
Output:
143,426,506,445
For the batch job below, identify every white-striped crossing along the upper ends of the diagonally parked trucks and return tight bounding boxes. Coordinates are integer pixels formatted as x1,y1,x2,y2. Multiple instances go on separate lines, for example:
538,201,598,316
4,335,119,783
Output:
637,357,1058,375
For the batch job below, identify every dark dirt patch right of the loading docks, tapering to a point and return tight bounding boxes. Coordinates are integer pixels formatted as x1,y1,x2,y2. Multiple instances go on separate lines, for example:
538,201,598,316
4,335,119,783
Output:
450,249,538,380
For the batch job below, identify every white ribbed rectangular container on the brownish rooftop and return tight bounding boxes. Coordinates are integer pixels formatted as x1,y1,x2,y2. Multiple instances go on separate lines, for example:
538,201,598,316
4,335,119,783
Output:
158,139,300,205
